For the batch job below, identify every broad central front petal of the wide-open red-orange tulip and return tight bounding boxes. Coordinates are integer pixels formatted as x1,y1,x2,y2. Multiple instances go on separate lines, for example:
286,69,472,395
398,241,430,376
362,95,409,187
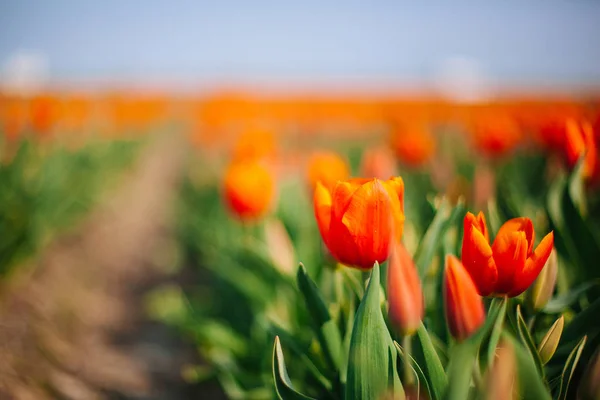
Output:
492,229,528,294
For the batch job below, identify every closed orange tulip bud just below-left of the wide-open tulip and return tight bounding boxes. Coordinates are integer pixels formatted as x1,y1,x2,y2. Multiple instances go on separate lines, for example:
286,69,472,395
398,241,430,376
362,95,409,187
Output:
444,254,485,340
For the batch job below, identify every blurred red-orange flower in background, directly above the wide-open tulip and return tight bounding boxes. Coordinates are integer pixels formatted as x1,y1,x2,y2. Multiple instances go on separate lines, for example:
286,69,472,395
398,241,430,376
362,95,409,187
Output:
473,114,523,157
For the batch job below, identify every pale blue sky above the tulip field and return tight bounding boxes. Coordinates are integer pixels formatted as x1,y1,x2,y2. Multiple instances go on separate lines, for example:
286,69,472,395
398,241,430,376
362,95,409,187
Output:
0,0,600,84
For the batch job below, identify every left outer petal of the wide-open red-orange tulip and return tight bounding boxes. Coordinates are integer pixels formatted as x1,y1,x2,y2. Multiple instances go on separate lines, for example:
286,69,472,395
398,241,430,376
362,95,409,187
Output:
462,222,498,296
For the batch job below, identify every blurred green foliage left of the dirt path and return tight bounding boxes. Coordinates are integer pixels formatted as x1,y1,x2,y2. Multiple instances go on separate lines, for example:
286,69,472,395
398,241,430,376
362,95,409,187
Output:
0,140,139,276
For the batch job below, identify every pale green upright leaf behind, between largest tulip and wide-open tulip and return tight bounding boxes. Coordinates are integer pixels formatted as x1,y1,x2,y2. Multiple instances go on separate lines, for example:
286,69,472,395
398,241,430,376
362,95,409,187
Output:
413,197,464,279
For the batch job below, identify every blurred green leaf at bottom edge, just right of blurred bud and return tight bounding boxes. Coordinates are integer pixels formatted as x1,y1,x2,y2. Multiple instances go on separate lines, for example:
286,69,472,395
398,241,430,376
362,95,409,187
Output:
502,333,552,400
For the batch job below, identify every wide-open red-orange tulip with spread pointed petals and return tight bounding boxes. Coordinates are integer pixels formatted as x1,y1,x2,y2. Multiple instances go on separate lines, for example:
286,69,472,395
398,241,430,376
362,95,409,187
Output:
462,212,554,297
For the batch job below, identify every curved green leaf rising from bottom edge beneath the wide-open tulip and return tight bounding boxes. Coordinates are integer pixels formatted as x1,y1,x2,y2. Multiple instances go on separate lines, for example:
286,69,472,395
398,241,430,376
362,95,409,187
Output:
444,299,507,400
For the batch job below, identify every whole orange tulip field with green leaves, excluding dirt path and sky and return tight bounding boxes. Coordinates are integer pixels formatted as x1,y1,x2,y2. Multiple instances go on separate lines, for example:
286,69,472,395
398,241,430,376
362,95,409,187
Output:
0,92,600,400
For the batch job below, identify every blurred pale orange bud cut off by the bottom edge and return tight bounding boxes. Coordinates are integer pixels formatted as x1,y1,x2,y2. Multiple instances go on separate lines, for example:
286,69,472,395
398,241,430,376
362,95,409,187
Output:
486,341,518,400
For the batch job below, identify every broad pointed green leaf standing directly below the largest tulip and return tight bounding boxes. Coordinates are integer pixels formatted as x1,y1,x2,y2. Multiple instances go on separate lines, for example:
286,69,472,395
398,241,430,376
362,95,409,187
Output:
345,263,404,400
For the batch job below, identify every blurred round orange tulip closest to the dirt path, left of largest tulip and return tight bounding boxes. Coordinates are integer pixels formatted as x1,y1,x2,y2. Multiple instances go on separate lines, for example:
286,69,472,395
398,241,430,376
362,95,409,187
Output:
224,161,275,220
